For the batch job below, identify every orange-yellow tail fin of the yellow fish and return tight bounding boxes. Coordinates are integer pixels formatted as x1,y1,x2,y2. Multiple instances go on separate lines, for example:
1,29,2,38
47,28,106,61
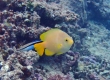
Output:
34,42,45,56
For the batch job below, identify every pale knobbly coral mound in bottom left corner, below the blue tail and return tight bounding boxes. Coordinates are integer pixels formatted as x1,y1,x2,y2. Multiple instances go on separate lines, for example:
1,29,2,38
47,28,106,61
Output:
0,51,39,80
